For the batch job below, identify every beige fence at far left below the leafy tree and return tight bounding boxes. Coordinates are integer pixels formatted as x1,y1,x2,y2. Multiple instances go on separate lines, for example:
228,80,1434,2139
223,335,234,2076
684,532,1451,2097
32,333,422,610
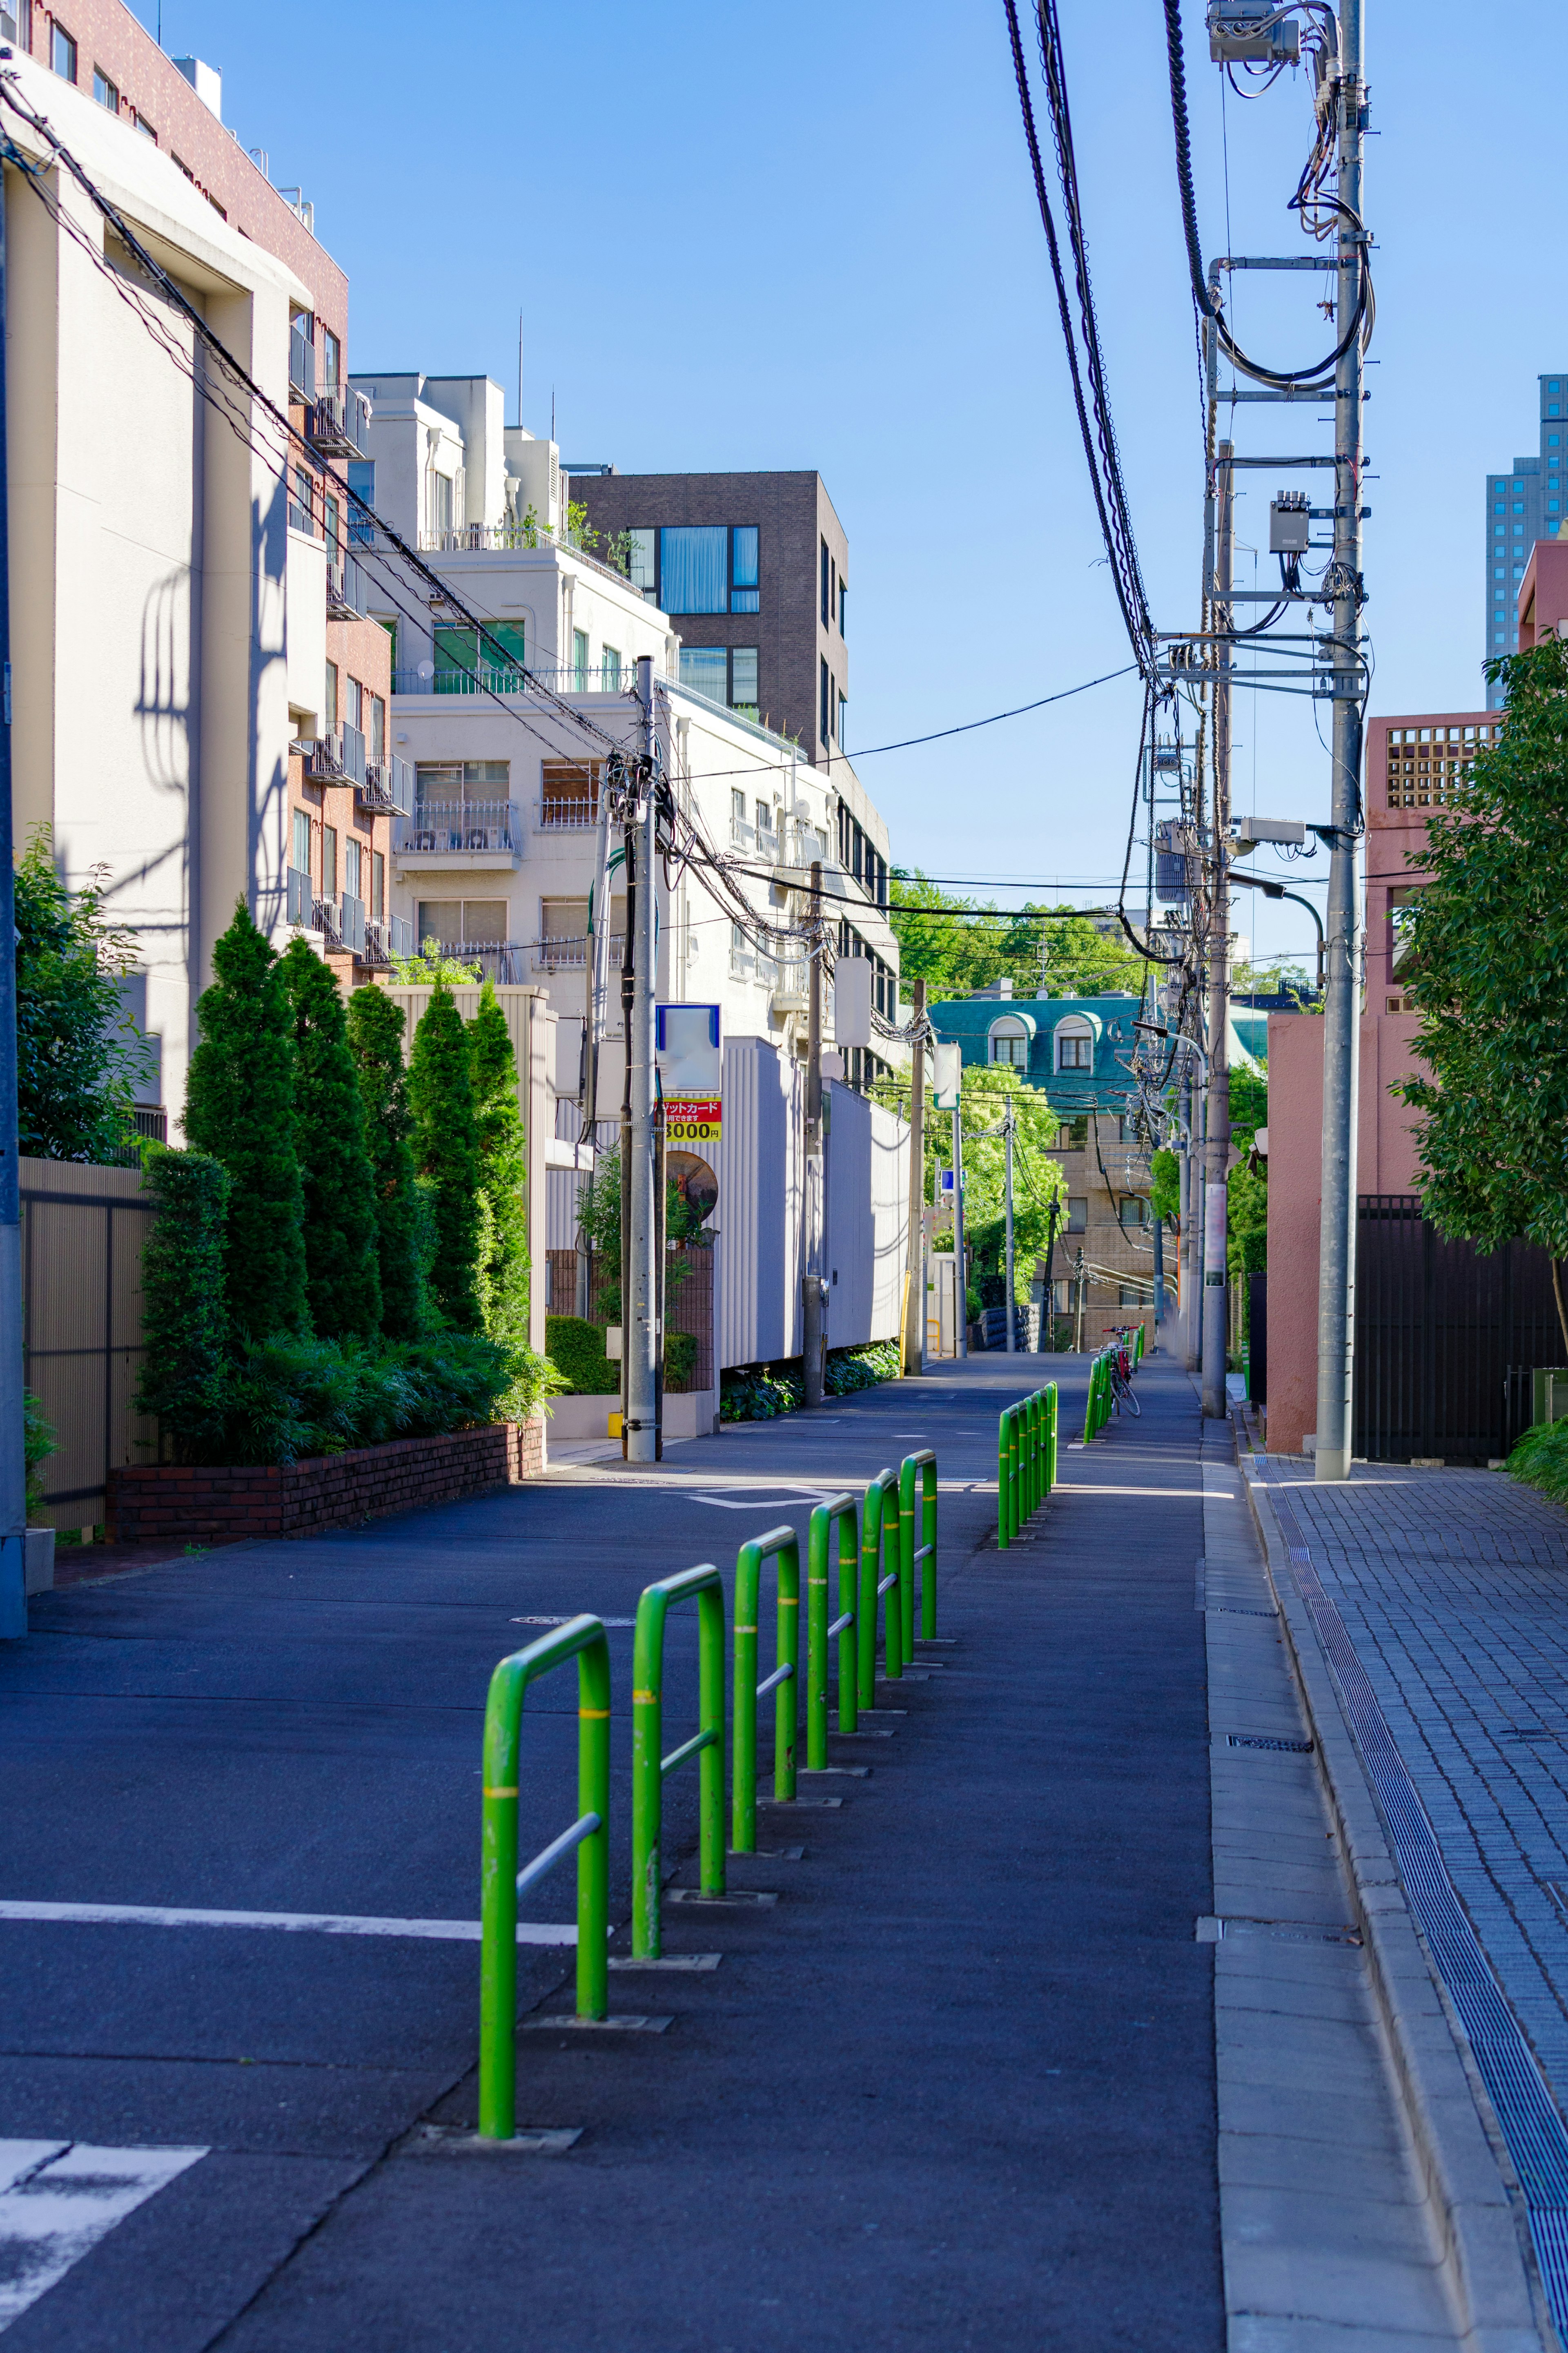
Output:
21,1160,158,1527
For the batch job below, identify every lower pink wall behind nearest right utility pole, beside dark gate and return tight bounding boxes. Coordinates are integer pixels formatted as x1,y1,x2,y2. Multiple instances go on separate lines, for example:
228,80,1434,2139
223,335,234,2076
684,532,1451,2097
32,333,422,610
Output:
1270,1014,1418,1454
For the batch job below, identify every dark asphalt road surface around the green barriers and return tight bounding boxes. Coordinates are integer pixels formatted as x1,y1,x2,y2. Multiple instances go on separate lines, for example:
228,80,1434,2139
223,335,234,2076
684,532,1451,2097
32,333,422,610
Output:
0,1358,1225,2353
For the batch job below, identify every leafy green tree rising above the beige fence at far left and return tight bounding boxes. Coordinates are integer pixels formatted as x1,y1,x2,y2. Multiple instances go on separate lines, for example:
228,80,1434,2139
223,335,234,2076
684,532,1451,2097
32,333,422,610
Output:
14,826,155,1165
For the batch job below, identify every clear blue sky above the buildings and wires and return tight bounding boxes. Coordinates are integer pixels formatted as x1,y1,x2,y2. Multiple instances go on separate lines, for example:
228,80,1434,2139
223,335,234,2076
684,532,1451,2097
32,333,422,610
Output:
139,0,1568,974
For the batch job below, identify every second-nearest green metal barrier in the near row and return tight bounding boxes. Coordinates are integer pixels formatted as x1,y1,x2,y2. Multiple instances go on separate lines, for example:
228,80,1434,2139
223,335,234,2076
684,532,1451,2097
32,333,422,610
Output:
633,1562,724,1960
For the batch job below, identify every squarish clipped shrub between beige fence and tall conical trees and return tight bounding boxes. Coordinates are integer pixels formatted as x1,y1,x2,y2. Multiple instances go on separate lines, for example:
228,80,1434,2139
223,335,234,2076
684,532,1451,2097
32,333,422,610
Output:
136,1146,230,1461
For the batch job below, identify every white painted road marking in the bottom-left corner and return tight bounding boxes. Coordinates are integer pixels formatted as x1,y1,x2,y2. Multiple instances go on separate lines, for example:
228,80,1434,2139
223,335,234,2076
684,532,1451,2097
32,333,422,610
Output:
0,2141,207,2329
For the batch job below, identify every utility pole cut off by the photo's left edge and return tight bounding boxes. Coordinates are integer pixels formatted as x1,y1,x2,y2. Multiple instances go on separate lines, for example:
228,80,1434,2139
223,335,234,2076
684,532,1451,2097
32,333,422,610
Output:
0,174,28,1640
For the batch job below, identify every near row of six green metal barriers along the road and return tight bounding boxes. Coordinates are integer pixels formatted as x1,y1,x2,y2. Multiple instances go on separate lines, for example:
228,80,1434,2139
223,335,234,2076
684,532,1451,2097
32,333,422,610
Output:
479,1440,940,2141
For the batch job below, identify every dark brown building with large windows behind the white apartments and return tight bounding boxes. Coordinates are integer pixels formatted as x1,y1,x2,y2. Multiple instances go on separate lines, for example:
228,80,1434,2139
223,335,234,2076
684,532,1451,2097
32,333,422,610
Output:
564,468,849,765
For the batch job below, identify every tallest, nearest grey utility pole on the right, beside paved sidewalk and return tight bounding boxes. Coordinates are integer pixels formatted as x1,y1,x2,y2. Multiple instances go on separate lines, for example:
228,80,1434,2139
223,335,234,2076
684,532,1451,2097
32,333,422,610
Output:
1312,0,1368,1480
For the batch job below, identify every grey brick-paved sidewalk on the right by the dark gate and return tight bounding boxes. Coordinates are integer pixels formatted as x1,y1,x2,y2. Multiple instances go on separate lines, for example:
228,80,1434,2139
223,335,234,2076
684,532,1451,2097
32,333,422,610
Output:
1248,1456,1568,2111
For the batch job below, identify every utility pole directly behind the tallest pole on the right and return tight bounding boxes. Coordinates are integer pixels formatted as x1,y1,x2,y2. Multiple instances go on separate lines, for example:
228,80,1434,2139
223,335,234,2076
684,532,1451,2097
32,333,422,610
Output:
1201,440,1236,1421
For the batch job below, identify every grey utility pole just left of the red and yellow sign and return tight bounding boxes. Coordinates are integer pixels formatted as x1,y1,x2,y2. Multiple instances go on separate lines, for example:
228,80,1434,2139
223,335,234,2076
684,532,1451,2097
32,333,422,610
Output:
621,654,663,1463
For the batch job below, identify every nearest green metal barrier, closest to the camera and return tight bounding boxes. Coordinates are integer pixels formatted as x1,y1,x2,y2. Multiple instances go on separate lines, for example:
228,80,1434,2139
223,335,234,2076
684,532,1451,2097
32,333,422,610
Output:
479,1617,609,2141
